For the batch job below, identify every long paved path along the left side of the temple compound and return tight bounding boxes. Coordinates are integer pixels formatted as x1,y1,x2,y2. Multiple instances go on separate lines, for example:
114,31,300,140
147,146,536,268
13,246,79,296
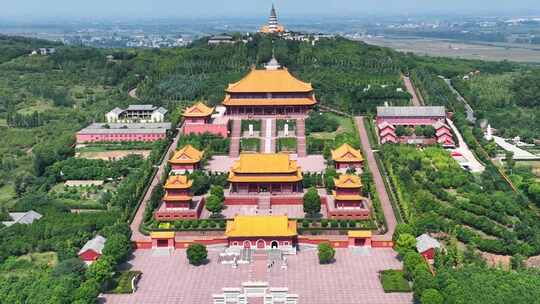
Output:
130,128,182,241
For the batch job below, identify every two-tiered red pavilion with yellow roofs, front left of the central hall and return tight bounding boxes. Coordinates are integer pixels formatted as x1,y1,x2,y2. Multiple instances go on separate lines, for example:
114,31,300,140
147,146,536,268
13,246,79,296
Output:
154,175,204,221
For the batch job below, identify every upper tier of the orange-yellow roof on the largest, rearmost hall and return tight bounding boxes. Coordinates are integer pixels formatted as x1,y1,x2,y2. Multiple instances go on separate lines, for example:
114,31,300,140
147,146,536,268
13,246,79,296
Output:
226,68,313,93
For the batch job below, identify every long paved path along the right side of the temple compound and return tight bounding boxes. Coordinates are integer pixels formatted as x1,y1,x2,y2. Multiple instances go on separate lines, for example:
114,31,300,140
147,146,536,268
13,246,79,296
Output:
355,116,396,240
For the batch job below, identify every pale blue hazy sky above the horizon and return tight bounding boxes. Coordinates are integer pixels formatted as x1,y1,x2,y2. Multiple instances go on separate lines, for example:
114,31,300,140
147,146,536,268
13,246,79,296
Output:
0,0,540,18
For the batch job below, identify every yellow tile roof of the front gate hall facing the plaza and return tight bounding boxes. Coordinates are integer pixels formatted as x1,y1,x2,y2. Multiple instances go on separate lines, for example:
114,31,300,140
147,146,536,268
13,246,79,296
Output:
225,216,297,237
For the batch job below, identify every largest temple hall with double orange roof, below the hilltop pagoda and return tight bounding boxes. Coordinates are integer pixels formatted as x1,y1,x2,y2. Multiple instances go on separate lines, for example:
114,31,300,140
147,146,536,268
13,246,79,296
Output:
223,58,317,116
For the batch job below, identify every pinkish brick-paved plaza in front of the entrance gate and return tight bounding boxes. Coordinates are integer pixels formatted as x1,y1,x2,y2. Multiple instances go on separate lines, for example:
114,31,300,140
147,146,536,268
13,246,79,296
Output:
101,249,412,304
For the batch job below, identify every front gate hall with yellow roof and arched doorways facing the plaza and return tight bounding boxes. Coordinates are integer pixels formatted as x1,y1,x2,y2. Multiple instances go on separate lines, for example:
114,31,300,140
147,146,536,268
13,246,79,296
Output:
225,216,298,253
